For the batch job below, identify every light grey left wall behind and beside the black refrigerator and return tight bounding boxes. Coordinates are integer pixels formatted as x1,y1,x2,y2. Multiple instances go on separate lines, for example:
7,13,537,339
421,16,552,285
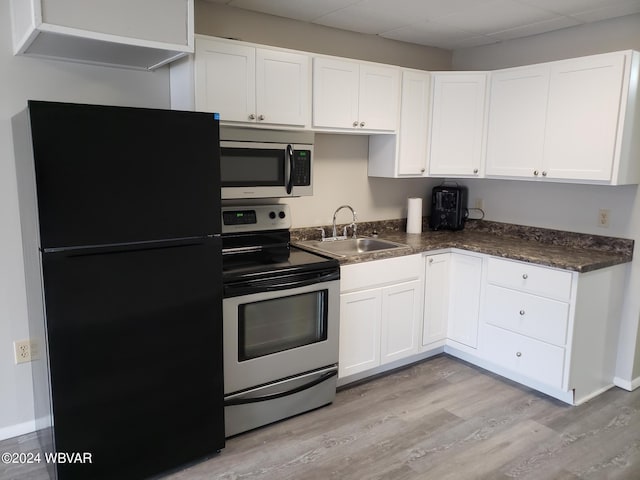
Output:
0,1,169,440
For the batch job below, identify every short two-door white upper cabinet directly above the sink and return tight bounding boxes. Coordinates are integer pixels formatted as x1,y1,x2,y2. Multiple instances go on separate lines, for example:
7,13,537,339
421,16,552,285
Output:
313,57,400,132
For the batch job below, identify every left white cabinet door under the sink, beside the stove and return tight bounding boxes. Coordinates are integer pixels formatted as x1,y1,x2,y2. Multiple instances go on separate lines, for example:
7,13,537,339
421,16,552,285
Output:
338,289,382,378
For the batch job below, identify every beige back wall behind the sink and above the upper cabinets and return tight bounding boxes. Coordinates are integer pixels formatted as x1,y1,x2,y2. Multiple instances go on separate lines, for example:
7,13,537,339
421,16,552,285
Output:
195,0,451,227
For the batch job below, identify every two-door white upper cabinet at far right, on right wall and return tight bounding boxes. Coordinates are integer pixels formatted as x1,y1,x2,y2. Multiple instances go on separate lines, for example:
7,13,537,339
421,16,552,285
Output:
486,51,640,185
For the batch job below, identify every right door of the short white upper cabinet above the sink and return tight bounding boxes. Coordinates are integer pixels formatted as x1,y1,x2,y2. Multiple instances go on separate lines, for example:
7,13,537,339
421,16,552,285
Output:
358,64,400,131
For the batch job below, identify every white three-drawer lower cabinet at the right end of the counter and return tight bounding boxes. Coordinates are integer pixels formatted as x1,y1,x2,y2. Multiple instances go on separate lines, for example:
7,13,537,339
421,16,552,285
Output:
478,257,626,404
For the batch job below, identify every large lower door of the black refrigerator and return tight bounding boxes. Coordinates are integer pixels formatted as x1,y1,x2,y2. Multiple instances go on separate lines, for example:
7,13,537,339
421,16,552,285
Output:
43,238,224,479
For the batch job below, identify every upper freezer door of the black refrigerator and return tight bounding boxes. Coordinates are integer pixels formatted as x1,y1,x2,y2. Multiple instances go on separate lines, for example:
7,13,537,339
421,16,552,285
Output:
29,101,220,248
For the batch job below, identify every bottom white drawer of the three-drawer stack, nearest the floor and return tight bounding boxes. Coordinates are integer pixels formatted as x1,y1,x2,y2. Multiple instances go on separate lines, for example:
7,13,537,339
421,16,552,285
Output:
482,325,565,389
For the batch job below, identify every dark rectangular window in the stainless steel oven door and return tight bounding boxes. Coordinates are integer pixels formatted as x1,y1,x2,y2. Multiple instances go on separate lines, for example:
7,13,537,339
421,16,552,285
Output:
238,290,329,361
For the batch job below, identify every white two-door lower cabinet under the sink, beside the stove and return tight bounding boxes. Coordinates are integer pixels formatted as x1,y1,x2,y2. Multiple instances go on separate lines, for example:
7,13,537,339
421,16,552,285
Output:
338,255,423,379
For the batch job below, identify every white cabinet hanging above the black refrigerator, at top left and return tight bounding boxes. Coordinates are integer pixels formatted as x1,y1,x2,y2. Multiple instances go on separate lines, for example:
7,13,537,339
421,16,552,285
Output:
11,0,193,69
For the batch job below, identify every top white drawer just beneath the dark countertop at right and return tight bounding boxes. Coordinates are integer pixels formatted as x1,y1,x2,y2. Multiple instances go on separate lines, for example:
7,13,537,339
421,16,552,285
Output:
487,258,572,301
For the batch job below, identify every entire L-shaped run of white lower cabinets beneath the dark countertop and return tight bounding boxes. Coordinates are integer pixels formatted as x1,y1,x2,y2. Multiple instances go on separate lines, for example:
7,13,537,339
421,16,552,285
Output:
339,249,628,404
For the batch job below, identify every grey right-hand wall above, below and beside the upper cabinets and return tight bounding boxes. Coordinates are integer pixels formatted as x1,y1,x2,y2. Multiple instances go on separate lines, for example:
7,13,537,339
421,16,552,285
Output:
453,14,640,388
